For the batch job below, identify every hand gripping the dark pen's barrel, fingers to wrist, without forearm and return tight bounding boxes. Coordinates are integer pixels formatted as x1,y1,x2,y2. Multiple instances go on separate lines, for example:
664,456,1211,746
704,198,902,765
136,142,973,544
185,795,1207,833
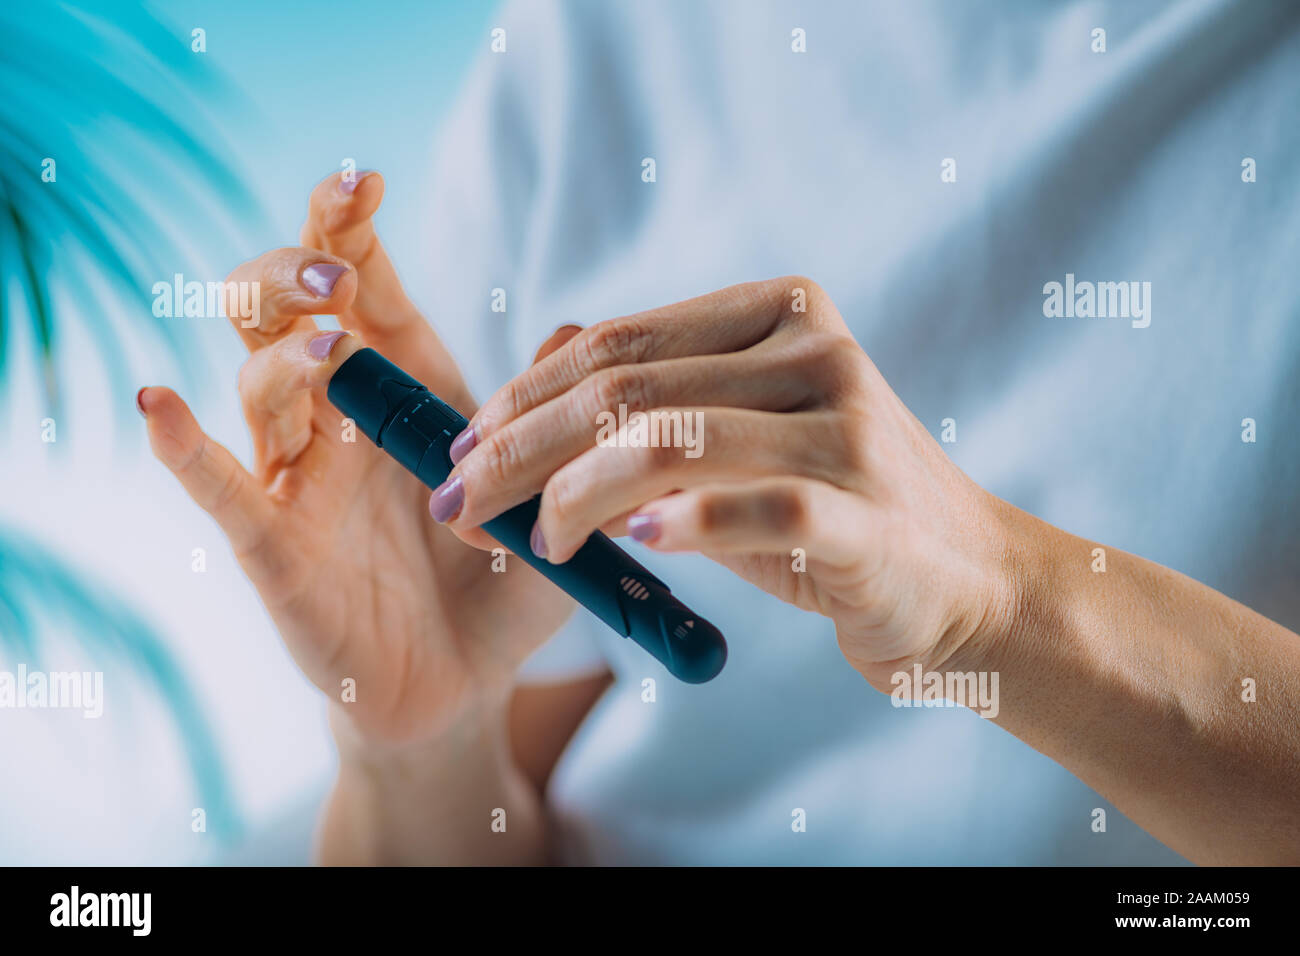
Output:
432,277,1017,689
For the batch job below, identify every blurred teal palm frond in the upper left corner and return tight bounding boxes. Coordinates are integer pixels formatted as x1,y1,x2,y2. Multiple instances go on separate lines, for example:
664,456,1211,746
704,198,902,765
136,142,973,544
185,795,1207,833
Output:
0,3,264,418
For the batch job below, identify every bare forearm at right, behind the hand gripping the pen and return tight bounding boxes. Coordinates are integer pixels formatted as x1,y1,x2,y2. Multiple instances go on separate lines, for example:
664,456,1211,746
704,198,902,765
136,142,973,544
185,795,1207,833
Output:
943,502,1300,864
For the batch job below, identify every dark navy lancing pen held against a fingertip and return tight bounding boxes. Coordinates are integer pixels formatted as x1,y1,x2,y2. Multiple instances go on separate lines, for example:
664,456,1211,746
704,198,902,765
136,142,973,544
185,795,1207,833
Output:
326,349,727,684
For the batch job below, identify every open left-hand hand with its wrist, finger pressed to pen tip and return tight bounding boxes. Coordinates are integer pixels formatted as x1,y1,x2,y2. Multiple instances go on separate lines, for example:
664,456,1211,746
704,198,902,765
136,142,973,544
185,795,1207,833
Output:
138,173,592,864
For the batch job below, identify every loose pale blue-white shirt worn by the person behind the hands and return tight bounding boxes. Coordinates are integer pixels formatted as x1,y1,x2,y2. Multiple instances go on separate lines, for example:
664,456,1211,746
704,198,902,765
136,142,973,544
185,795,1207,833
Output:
424,0,1300,864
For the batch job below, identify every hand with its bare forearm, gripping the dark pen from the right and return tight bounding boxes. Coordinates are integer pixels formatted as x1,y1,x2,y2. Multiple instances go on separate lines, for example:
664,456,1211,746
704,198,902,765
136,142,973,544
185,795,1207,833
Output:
436,270,1300,864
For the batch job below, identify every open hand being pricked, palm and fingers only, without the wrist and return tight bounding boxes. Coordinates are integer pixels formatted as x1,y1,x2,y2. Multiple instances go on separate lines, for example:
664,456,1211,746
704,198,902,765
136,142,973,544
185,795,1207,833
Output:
137,173,576,744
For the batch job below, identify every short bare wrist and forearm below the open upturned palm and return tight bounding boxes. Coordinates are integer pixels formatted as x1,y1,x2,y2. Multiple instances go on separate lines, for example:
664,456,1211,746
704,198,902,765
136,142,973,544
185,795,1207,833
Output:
319,705,546,865
